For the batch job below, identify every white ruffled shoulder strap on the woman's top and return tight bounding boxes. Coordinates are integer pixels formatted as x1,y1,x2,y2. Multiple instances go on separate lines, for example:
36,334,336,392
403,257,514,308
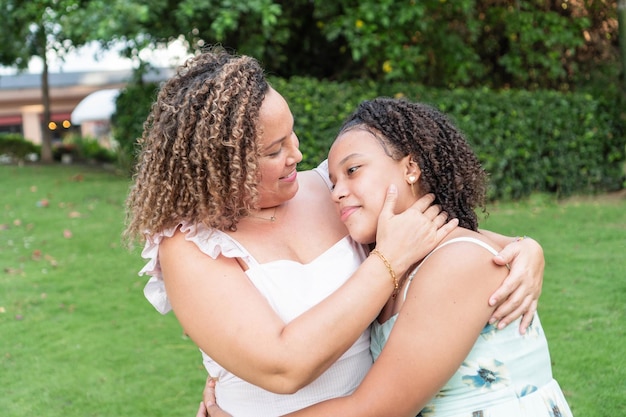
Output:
139,222,258,314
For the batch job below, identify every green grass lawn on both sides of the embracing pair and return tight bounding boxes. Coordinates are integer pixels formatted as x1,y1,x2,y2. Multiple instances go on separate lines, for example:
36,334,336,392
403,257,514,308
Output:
0,166,626,417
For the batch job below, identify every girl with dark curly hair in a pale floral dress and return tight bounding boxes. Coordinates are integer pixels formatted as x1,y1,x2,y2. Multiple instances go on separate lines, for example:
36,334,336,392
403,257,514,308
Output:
201,98,572,417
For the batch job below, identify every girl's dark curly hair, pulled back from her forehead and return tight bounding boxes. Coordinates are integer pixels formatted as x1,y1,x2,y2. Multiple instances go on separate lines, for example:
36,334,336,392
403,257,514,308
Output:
340,97,487,231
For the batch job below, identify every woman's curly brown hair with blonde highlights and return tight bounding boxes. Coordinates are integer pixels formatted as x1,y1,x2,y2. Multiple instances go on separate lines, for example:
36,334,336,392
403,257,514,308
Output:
124,48,269,241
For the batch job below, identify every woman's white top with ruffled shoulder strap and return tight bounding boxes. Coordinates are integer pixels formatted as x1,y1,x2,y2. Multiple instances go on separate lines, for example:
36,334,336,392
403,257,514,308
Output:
140,161,372,417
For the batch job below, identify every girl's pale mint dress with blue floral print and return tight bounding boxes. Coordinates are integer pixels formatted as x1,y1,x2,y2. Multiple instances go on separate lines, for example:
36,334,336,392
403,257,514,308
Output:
370,238,572,417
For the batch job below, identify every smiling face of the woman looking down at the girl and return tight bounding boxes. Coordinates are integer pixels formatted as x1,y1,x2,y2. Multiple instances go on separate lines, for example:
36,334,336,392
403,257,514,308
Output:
258,88,302,208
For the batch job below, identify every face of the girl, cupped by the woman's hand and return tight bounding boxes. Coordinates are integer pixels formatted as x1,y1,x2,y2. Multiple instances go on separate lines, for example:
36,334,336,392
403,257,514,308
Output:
328,127,419,244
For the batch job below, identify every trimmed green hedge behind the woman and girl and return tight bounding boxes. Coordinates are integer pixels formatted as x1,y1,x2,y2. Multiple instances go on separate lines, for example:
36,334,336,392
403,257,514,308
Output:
114,77,626,200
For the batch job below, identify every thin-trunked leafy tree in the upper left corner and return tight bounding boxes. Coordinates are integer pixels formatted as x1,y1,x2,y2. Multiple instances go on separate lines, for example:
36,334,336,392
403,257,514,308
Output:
0,0,154,163
